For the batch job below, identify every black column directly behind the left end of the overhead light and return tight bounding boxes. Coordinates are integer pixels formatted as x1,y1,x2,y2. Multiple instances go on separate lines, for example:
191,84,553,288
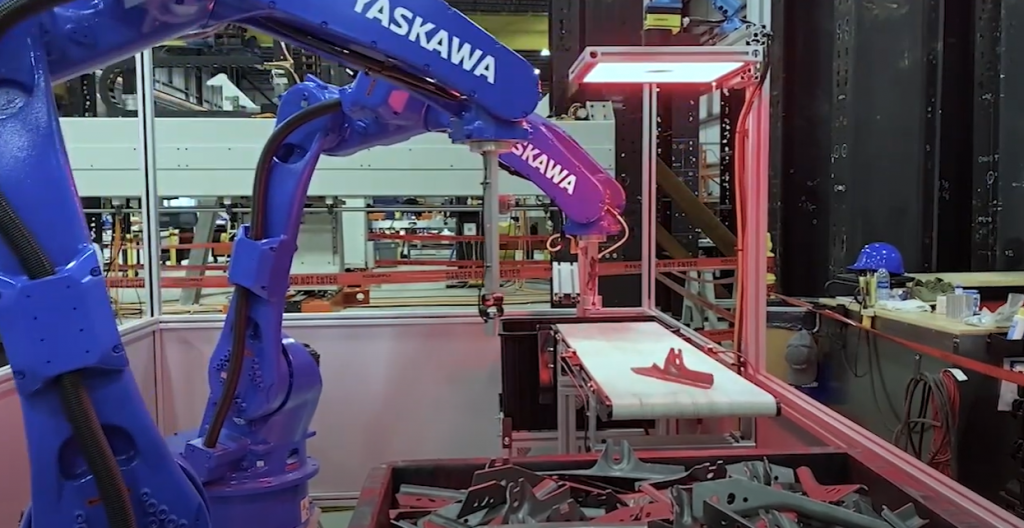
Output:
549,0,645,308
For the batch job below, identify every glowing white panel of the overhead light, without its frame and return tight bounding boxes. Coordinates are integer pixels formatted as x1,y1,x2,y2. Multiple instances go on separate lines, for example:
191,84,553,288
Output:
580,62,745,84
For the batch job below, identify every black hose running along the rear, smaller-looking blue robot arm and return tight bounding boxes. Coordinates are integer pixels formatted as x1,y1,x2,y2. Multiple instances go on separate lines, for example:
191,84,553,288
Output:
203,99,341,449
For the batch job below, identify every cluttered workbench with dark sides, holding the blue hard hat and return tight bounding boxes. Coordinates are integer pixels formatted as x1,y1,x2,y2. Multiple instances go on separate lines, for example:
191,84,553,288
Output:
819,296,1016,500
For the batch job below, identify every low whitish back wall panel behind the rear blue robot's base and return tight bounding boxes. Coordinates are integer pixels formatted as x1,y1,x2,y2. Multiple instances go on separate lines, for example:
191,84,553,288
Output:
161,321,501,493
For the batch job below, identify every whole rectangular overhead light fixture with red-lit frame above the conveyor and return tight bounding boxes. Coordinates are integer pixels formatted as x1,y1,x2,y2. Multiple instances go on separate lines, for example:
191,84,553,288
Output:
569,46,763,91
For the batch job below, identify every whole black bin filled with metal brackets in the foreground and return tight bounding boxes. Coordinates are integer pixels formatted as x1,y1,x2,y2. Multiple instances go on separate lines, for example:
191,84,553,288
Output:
349,441,958,528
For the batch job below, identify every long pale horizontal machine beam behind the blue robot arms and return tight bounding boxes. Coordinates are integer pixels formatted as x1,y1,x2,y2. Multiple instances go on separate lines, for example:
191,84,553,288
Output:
61,118,615,197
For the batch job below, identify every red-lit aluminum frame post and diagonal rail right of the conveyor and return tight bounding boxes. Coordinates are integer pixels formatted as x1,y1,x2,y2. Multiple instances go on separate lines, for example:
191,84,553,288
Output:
570,47,1024,527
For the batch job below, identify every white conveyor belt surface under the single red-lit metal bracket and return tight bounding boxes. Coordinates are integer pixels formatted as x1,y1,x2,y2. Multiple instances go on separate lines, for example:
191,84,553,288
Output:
558,322,778,420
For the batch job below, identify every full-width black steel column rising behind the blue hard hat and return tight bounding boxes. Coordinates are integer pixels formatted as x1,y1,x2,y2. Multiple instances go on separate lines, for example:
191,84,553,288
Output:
773,0,962,295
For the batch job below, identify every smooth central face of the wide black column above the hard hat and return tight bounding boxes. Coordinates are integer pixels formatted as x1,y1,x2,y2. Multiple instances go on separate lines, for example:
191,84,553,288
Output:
829,0,949,271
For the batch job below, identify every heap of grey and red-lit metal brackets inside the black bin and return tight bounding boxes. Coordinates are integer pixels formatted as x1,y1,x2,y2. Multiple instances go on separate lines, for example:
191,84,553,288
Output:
390,442,927,528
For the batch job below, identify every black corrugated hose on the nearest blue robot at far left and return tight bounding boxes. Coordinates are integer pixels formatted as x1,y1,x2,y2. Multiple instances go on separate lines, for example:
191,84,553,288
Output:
0,0,136,528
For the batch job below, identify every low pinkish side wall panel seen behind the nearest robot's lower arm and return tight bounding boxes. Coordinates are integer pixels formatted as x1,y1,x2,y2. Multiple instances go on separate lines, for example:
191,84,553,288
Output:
0,321,157,526
